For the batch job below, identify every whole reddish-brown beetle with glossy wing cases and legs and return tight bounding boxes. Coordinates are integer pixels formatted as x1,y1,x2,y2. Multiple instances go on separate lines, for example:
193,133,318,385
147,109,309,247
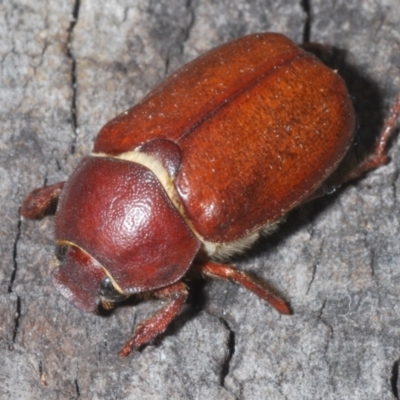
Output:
21,33,400,356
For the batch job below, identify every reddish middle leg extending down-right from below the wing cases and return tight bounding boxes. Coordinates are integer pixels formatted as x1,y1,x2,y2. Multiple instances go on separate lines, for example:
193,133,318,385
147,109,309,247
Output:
200,262,292,315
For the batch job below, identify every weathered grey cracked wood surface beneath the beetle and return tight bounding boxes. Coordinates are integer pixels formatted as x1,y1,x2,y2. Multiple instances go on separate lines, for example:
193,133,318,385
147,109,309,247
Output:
0,0,400,400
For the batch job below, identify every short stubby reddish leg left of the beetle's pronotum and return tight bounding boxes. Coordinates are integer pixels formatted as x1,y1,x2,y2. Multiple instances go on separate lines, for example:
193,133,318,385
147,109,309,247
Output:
21,182,65,219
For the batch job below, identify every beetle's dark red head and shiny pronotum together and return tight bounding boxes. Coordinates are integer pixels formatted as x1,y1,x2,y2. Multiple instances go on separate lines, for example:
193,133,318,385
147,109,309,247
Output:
53,157,200,311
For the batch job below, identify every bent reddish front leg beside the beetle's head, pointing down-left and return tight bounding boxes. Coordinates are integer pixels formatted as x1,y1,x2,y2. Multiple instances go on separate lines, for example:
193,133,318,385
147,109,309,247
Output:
118,282,188,357
